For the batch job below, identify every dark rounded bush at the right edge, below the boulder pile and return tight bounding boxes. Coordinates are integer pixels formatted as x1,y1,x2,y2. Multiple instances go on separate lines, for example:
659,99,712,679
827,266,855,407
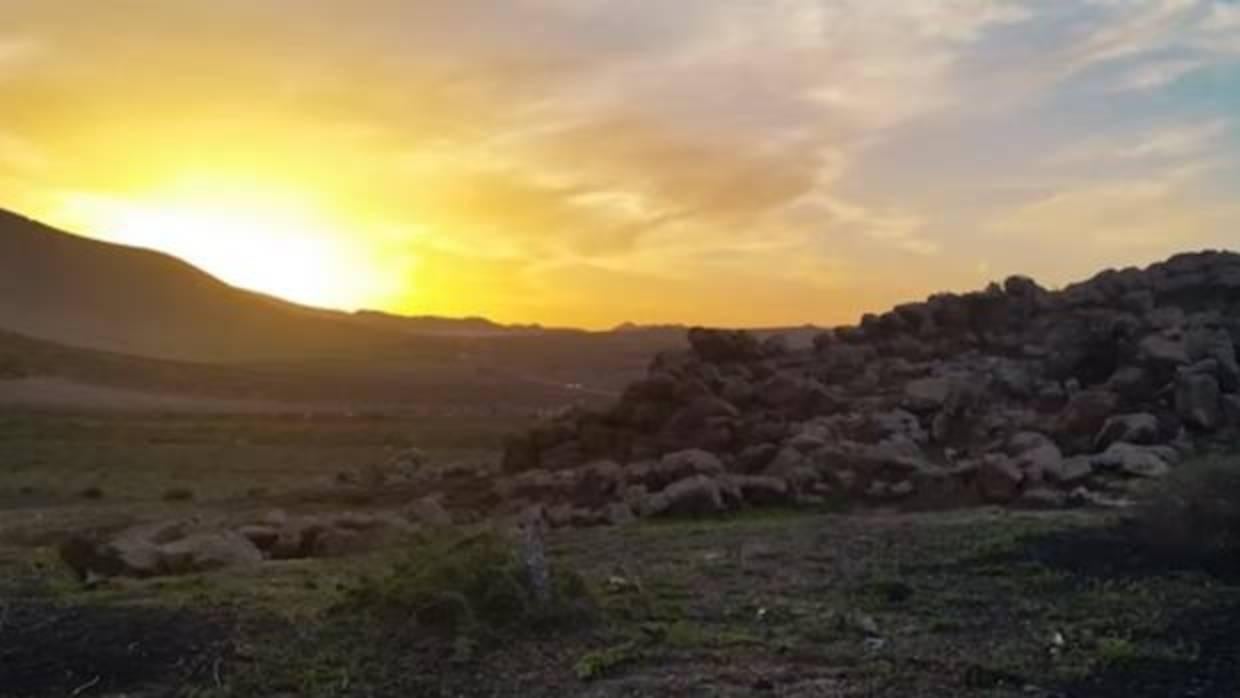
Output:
1132,459,1240,570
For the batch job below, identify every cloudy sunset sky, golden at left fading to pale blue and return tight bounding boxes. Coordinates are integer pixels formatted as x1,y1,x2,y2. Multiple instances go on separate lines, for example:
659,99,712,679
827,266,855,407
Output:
0,0,1240,327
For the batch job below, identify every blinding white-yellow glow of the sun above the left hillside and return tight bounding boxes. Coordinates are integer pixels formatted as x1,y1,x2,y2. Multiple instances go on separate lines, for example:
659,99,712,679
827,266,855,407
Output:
58,179,392,310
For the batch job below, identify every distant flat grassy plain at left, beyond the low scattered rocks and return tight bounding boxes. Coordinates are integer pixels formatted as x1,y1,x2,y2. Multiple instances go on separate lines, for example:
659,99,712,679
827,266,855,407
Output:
0,410,520,506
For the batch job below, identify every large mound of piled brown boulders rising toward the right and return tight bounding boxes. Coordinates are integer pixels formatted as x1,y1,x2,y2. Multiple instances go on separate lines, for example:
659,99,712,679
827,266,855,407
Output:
495,252,1240,524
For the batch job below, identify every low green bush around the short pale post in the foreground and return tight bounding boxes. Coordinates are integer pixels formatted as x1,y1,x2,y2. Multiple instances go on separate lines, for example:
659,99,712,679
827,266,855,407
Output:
345,533,594,635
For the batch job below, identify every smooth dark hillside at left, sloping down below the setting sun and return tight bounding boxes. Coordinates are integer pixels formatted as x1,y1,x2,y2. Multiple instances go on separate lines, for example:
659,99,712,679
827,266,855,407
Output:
0,210,532,362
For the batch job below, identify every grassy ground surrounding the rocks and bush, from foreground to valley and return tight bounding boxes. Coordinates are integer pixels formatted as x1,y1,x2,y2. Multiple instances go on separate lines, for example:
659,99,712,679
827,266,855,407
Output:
0,412,1240,698
